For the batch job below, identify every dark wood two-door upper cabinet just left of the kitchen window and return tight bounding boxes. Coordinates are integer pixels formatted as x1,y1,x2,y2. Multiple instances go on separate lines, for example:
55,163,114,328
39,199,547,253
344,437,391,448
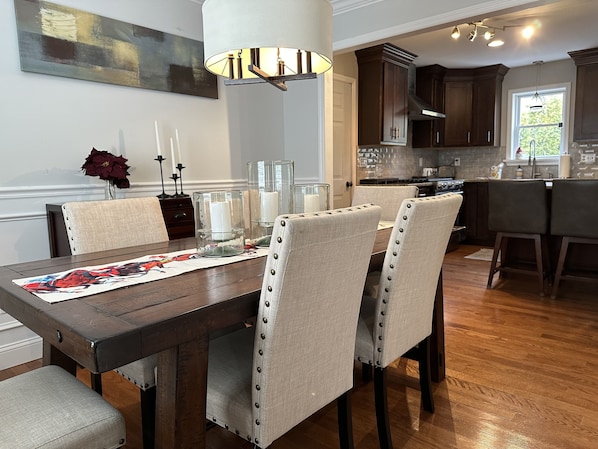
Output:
443,64,509,147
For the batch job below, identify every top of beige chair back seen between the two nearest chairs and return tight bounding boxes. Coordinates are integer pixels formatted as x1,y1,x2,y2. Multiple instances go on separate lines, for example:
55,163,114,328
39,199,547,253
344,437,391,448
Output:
351,186,419,221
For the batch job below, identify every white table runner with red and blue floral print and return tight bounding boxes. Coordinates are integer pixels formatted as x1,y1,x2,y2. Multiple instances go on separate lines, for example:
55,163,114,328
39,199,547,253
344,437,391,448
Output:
13,248,268,303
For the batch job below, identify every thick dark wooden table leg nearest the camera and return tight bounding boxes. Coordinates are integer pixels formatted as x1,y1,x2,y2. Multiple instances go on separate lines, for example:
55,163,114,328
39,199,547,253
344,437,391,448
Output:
156,331,209,449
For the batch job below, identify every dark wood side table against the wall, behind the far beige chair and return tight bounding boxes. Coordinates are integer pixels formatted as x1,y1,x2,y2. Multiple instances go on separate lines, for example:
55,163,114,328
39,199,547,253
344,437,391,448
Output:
46,197,195,257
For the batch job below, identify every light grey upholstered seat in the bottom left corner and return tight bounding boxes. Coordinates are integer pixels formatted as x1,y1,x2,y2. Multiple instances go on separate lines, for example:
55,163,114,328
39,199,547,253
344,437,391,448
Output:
0,365,126,449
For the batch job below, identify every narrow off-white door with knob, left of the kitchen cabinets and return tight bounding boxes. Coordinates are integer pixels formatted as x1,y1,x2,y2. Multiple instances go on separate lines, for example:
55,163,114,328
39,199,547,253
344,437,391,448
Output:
332,75,357,209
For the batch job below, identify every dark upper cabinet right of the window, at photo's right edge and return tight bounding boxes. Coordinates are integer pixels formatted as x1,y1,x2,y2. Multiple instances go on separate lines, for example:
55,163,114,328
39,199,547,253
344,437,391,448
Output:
569,48,598,142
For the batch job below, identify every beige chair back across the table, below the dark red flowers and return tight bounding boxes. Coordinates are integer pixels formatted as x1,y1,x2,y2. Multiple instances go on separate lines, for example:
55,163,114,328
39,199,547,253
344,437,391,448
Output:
62,197,168,255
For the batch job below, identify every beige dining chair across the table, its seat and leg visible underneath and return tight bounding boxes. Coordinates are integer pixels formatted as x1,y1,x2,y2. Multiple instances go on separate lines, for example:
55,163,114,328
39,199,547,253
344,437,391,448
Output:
62,197,168,449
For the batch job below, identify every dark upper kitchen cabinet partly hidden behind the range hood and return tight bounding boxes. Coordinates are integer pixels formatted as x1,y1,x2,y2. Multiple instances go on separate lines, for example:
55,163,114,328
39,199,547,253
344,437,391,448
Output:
411,64,446,148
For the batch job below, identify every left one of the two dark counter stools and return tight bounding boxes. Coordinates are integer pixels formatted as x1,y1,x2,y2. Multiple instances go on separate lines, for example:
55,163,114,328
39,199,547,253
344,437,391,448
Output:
487,180,550,296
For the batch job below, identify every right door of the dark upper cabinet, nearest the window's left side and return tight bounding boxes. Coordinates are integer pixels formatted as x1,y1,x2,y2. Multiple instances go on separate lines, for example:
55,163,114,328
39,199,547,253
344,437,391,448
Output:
471,77,500,146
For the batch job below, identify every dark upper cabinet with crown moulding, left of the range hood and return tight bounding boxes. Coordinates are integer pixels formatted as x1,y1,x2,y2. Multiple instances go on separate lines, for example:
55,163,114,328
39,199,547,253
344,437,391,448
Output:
355,44,416,145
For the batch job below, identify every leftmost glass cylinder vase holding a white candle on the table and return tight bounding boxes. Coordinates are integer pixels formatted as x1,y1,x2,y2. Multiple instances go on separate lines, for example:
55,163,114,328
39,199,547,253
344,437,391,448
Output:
193,190,245,257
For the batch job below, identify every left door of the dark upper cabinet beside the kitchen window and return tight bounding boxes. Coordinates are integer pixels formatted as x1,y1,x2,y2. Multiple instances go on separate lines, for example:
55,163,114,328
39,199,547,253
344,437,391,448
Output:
444,81,473,147
